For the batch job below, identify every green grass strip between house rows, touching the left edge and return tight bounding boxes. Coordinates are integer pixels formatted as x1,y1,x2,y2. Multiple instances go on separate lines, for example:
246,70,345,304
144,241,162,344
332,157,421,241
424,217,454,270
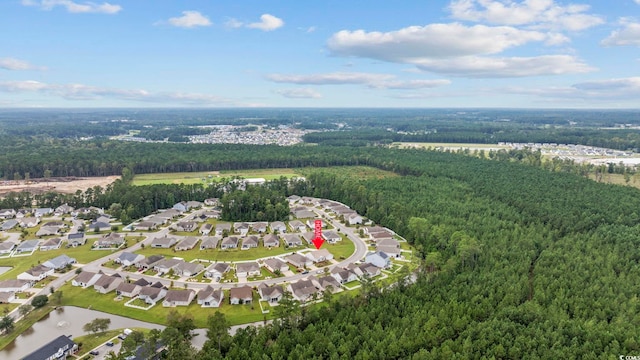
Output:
0,243,111,280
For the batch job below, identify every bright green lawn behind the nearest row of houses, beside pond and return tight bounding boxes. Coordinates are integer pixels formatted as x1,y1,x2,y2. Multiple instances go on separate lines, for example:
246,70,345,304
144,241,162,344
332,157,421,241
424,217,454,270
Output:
60,284,272,328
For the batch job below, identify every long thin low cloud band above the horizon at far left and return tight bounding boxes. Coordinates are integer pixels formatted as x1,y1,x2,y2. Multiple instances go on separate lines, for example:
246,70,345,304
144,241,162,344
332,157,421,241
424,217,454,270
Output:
0,80,231,105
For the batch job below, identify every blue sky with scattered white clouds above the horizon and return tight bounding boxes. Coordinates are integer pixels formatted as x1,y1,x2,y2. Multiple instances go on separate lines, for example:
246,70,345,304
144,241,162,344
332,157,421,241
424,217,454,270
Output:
0,0,640,109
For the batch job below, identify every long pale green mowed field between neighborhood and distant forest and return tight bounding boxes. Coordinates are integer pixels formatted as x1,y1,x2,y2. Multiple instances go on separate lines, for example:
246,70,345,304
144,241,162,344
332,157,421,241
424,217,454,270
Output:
133,169,301,185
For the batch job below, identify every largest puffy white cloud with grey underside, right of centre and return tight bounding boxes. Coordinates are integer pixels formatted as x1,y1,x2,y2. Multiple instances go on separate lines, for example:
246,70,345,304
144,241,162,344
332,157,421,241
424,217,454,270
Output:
327,23,549,63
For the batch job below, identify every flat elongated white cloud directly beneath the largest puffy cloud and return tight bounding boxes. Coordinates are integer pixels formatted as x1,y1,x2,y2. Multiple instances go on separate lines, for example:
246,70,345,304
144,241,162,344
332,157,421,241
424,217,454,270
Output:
416,55,595,78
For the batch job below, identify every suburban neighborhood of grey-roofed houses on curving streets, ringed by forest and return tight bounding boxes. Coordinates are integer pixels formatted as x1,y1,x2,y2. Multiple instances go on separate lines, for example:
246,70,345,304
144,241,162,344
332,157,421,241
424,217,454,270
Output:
0,195,411,356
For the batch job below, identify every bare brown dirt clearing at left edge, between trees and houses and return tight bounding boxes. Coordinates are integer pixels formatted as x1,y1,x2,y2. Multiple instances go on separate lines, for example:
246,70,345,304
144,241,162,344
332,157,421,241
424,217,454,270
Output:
0,176,120,195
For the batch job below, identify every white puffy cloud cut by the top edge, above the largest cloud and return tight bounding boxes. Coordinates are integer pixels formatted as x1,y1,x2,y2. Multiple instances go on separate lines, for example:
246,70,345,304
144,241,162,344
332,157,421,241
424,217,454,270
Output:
449,0,604,31
